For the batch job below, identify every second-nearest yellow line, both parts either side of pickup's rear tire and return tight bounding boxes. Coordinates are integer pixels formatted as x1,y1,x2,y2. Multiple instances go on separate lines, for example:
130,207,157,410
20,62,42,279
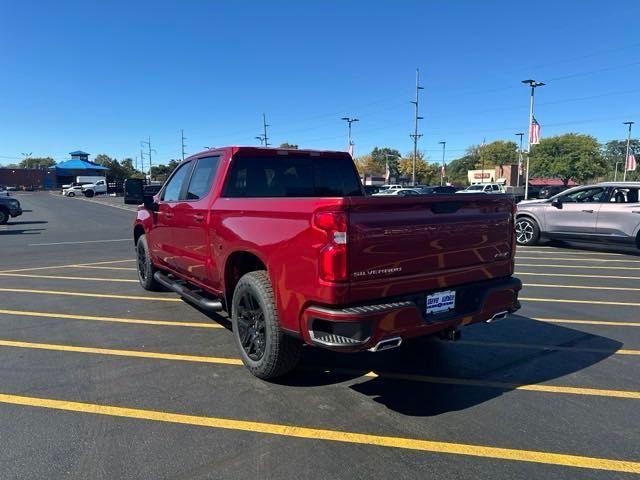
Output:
0,340,640,400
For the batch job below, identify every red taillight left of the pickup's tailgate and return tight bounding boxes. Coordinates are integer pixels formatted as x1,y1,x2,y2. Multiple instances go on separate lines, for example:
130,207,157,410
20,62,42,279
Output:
313,211,348,282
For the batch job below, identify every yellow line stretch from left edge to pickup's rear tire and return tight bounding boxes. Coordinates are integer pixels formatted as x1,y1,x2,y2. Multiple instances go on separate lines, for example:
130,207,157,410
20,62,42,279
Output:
0,340,242,365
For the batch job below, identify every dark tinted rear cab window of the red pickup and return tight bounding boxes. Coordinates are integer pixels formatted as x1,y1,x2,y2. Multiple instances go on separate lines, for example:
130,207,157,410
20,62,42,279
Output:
222,155,363,197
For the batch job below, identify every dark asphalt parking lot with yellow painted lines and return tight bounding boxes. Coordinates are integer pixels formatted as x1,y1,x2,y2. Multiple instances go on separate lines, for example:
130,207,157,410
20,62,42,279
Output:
0,192,640,479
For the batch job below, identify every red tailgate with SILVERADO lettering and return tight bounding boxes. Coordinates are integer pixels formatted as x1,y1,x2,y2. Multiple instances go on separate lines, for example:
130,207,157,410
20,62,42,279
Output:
348,194,513,300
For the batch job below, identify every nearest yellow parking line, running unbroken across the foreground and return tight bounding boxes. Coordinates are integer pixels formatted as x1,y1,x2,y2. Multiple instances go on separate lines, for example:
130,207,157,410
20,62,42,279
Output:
0,394,640,473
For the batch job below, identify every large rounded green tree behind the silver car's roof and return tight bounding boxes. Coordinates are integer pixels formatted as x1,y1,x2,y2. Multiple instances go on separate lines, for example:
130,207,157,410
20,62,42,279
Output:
530,133,607,186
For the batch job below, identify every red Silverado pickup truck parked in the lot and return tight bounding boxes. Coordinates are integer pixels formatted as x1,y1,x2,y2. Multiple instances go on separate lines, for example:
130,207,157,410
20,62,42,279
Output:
133,147,521,379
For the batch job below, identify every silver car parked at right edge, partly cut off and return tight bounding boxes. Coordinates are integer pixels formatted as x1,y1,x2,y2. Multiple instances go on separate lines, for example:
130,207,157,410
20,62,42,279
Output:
516,182,640,248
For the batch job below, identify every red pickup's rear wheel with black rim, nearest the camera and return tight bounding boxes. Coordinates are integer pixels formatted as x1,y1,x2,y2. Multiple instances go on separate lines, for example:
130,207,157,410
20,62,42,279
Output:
231,270,302,380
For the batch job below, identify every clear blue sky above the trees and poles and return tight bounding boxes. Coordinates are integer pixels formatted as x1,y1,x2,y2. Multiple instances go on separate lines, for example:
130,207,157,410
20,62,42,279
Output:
0,0,640,164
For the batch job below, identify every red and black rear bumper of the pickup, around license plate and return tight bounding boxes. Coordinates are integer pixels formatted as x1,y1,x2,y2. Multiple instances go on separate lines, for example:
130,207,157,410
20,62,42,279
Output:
302,277,522,351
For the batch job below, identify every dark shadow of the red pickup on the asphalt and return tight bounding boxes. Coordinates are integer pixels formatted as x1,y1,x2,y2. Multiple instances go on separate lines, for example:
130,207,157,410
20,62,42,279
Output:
278,315,622,416
